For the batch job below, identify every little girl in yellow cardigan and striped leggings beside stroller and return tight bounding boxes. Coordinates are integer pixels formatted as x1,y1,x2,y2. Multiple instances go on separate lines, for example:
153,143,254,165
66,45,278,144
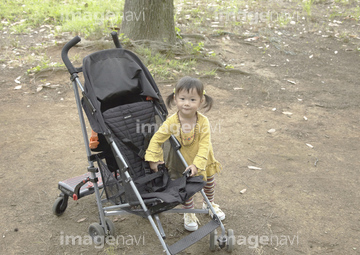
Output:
145,77,225,231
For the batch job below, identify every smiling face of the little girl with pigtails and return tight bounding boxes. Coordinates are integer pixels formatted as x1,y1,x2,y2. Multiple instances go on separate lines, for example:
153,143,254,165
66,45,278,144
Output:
175,89,203,118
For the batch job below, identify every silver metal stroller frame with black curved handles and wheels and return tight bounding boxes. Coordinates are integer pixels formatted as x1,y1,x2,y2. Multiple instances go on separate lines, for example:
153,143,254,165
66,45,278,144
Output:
53,32,235,255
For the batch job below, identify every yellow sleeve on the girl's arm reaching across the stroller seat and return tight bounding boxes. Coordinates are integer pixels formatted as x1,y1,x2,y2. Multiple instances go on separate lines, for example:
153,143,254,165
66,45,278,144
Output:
145,115,176,162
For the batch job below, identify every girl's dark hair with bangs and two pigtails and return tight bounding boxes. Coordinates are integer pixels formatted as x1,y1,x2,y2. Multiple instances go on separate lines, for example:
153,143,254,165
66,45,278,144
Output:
166,76,214,112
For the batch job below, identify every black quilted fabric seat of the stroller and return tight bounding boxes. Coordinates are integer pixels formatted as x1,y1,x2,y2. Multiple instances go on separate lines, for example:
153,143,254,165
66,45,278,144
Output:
98,100,205,215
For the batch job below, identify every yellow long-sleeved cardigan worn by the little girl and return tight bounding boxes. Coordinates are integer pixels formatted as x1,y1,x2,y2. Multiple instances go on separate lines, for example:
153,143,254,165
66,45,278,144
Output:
145,112,221,179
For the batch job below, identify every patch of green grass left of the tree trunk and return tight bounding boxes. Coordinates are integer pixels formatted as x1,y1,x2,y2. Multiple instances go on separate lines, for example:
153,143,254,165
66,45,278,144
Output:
0,0,124,37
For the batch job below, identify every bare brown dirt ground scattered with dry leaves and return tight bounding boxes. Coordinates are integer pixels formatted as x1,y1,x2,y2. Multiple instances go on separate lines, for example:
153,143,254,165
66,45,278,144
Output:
0,2,360,255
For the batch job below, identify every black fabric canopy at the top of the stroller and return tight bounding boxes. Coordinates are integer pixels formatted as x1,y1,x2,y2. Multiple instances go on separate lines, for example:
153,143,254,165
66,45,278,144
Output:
82,48,167,133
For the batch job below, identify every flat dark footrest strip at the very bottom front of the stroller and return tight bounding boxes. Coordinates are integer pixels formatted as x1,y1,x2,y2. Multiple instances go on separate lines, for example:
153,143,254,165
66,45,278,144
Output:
169,220,220,254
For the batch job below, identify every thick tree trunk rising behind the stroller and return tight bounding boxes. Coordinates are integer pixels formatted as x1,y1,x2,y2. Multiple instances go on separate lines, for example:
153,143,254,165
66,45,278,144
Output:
121,0,175,44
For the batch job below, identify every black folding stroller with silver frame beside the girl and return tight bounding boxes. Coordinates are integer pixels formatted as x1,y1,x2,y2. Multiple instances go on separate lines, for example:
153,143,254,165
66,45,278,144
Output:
53,32,235,254
